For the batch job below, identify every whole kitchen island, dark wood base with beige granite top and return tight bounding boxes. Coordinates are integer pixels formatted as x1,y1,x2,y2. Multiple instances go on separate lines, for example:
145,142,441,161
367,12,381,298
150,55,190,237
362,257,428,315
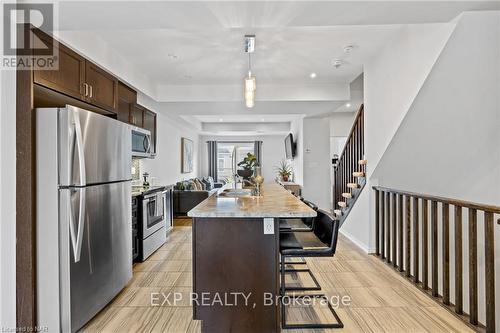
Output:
188,183,316,332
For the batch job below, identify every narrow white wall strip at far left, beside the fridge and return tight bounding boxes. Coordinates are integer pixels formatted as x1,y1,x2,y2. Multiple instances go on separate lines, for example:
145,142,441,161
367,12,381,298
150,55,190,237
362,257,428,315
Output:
0,70,16,328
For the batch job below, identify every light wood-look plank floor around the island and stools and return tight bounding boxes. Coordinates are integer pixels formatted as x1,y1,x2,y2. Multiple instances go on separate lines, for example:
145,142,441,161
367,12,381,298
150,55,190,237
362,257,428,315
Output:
82,219,472,333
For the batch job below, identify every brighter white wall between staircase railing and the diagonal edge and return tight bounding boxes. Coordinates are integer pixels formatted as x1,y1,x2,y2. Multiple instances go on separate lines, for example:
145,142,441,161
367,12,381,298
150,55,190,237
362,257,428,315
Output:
341,23,455,252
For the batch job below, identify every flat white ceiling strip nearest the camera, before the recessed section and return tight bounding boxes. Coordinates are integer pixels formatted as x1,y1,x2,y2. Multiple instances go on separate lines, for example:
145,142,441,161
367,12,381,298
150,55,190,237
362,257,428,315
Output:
57,0,499,31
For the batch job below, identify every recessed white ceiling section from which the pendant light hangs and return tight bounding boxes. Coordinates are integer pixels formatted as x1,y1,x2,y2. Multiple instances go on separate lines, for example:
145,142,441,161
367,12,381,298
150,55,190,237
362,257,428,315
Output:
82,26,399,86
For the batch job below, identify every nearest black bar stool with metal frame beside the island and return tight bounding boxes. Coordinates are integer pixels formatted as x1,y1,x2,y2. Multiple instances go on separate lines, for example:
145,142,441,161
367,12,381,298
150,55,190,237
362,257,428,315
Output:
280,209,344,329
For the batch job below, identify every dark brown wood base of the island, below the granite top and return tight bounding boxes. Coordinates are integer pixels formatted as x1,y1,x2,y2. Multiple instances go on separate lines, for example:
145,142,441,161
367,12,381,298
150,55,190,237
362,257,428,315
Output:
192,217,281,333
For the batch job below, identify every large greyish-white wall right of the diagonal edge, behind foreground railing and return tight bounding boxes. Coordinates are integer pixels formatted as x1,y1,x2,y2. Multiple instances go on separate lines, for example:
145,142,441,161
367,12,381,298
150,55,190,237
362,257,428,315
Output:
343,12,500,330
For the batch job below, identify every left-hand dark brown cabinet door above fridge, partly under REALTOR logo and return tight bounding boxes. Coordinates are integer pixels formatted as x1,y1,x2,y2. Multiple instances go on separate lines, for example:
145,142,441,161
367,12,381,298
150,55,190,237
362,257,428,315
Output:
33,31,85,99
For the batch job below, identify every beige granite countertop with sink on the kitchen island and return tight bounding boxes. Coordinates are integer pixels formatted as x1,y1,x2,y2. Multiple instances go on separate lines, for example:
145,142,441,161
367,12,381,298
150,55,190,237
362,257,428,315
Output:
188,183,316,218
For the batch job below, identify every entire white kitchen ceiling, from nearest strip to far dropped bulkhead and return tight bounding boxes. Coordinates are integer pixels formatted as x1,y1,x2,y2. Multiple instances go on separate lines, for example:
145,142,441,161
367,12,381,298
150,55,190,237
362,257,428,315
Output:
51,1,500,134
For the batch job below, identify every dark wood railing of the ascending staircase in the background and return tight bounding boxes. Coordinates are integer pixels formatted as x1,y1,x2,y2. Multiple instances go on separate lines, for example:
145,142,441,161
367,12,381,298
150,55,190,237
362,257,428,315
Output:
333,104,365,209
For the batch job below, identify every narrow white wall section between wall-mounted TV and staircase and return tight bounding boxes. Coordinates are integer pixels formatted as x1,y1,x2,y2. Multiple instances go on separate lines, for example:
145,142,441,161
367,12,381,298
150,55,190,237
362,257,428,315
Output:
302,118,331,210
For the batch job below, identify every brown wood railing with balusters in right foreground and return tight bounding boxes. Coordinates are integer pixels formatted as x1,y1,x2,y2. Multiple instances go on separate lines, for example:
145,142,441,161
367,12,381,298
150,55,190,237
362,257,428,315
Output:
373,186,500,332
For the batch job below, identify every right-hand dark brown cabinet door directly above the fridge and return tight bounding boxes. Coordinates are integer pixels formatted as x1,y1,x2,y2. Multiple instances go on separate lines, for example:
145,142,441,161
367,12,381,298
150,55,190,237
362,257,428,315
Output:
84,60,118,112
